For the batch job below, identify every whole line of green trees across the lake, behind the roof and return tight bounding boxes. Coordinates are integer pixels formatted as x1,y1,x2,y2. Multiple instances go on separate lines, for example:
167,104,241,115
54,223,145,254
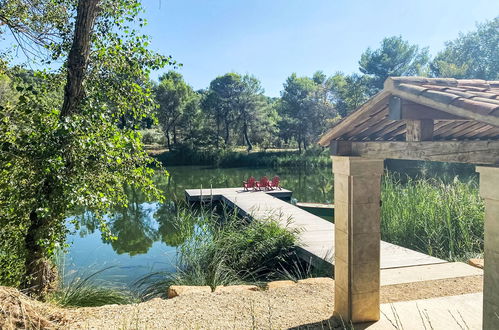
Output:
153,17,499,151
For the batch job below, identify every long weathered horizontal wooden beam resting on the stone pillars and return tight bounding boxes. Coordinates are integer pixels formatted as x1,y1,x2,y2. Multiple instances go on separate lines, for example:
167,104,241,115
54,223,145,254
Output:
331,141,499,165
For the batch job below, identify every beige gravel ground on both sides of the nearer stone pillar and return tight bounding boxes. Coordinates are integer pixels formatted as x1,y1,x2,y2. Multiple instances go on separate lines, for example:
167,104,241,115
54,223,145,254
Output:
67,276,483,329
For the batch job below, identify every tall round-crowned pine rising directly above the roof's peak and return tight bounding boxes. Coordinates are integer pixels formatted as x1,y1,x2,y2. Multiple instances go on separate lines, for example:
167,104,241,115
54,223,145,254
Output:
359,36,429,92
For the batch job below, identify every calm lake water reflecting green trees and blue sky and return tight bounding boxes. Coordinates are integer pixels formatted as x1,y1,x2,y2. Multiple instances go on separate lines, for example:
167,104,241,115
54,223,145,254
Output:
63,166,333,283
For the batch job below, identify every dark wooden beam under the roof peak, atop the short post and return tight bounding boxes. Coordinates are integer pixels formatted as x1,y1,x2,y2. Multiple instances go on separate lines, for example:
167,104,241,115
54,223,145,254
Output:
388,95,466,120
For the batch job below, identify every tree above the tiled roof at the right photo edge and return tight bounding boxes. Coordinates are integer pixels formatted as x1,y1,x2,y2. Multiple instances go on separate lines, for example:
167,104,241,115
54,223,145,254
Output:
431,17,499,80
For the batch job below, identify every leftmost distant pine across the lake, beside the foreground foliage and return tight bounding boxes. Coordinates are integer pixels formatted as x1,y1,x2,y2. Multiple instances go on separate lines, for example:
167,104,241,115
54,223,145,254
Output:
156,71,194,148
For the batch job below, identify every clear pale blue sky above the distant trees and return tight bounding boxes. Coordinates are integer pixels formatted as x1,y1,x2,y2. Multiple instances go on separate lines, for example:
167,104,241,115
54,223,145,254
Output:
143,0,499,96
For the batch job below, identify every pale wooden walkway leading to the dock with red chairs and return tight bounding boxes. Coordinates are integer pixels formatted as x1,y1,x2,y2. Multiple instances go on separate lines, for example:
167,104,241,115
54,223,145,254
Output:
185,188,447,269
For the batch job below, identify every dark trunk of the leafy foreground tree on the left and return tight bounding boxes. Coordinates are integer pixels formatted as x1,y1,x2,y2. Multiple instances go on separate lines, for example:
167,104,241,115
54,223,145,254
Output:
22,0,99,297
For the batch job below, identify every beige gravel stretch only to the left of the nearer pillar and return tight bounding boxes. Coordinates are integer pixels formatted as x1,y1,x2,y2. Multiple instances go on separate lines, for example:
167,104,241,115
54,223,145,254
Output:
68,284,334,329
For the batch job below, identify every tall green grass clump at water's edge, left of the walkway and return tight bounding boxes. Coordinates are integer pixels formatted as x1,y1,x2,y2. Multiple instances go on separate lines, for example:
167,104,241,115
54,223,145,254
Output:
136,206,297,299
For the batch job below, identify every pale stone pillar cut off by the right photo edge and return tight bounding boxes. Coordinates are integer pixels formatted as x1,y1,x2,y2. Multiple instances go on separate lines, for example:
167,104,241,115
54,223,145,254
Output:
477,167,499,330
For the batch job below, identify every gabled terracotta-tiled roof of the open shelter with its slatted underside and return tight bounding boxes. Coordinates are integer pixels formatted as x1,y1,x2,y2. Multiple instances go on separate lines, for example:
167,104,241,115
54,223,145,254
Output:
319,77,499,145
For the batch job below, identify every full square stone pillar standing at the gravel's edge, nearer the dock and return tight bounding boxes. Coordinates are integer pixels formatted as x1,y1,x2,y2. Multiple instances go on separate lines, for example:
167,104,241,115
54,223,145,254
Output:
332,156,383,323
